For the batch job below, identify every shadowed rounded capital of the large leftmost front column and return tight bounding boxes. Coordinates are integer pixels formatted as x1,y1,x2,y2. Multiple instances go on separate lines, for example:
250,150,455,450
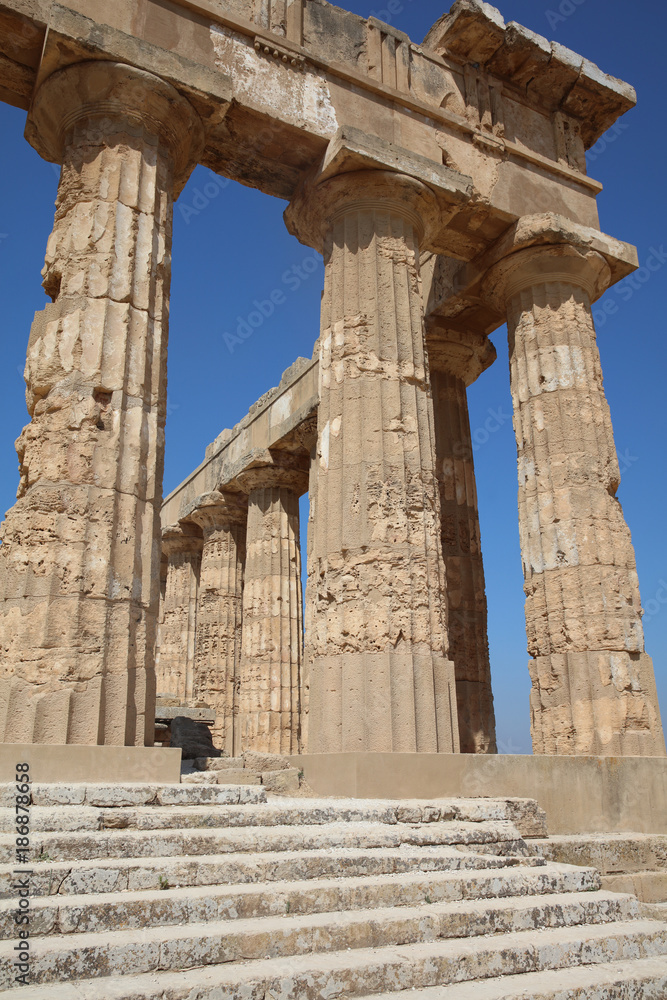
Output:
25,59,204,195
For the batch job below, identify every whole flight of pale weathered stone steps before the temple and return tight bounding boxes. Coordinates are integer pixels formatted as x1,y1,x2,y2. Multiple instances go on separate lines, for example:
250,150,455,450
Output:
0,784,667,1000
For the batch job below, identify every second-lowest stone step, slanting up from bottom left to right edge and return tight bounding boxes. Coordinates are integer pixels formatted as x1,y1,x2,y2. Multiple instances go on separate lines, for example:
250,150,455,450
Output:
3,920,667,1000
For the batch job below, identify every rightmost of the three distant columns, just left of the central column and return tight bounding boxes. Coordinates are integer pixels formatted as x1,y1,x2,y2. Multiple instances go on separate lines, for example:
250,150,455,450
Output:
238,454,308,754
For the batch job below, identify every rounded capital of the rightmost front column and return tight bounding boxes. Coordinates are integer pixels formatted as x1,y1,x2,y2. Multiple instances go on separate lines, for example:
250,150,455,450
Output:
484,244,611,312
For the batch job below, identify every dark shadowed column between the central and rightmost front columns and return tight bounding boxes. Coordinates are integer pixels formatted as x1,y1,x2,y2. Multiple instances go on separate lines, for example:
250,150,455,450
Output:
427,327,496,753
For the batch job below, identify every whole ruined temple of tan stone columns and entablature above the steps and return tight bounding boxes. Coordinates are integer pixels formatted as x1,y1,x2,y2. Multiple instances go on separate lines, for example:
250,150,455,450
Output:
0,0,665,757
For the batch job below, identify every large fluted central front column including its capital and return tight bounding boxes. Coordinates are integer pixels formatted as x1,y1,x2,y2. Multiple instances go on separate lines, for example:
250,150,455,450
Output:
286,170,459,752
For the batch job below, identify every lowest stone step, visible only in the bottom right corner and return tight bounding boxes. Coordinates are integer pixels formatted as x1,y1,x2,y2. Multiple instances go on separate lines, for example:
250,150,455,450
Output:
359,957,667,1000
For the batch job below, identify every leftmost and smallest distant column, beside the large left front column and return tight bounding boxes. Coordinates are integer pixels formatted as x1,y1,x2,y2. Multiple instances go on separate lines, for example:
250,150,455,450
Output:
155,524,203,705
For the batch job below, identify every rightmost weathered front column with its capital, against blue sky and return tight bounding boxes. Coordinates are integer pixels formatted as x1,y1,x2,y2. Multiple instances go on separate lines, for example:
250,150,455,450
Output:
487,245,665,756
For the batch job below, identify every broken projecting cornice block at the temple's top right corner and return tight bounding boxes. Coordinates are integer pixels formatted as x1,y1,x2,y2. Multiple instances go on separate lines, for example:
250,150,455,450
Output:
423,0,637,148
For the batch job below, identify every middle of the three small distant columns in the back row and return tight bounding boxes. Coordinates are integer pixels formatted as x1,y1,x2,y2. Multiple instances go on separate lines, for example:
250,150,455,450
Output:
188,493,248,756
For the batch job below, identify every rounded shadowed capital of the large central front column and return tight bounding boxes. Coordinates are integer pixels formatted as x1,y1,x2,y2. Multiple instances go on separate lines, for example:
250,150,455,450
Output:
284,169,442,253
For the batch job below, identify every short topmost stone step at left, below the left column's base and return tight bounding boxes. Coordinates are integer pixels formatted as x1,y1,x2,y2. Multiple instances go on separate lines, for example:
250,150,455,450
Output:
0,782,266,812
